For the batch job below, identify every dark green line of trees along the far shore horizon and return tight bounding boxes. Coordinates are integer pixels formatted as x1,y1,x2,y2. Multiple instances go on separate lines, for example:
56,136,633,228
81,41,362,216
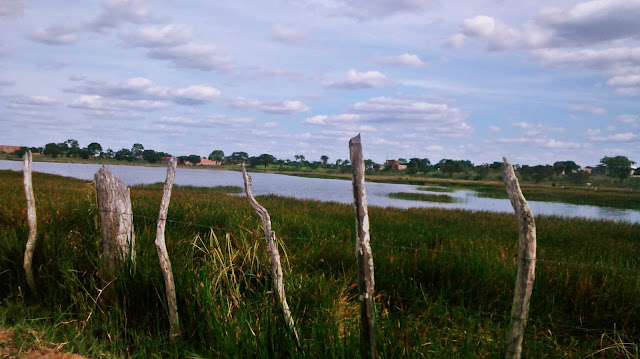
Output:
11,139,633,184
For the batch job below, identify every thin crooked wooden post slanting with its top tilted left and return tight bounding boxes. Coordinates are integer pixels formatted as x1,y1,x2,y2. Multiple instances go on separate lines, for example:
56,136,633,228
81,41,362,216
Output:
242,164,300,345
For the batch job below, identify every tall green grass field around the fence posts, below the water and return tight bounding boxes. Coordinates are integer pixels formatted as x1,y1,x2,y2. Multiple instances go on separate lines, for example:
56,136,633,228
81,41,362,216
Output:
0,171,640,358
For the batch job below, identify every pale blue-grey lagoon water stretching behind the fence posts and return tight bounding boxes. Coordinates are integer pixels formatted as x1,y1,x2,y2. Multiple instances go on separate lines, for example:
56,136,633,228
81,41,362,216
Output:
0,161,640,223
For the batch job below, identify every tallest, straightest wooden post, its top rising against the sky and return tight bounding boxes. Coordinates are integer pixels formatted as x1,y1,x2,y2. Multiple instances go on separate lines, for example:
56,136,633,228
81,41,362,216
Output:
349,134,378,358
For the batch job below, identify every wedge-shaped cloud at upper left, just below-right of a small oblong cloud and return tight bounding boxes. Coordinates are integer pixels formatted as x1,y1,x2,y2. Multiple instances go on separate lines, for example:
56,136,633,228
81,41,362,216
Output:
147,43,235,72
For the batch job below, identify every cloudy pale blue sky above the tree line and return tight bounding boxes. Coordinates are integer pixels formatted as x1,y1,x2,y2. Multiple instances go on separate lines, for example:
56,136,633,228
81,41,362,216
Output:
0,0,640,166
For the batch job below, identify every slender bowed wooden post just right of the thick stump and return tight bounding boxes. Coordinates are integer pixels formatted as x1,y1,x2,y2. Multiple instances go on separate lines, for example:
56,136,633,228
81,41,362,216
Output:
155,157,180,339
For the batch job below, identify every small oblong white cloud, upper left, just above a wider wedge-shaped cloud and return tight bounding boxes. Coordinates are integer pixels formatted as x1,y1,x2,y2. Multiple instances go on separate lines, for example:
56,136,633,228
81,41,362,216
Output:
118,24,192,48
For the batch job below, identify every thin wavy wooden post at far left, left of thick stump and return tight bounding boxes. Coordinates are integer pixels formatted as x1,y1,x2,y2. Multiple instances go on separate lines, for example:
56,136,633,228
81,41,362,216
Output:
22,150,38,293
